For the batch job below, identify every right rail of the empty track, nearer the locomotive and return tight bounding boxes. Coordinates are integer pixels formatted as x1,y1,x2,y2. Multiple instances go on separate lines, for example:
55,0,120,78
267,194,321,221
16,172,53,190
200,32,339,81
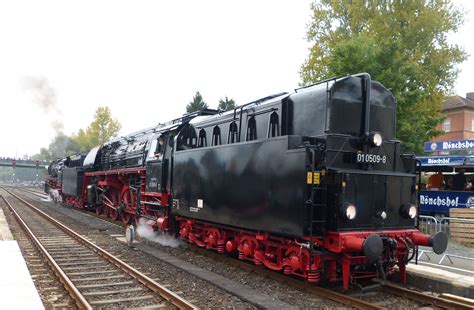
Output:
4,189,198,309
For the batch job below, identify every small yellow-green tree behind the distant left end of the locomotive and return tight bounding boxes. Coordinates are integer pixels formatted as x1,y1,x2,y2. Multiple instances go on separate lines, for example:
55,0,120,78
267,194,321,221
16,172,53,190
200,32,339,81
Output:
84,107,122,149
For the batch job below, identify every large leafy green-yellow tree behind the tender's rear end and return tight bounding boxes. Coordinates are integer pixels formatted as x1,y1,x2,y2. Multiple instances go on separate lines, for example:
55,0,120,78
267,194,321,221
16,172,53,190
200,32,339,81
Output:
300,0,467,153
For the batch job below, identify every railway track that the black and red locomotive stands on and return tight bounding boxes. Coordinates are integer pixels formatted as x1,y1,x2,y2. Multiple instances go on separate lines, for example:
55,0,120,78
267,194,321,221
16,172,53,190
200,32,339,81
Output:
10,186,473,309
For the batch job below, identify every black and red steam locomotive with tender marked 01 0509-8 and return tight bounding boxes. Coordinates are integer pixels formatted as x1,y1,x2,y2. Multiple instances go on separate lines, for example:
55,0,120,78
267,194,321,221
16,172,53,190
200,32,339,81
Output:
46,74,447,288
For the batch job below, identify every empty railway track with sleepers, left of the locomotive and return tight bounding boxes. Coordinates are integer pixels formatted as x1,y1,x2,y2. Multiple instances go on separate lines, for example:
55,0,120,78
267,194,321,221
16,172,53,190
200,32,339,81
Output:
2,188,196,309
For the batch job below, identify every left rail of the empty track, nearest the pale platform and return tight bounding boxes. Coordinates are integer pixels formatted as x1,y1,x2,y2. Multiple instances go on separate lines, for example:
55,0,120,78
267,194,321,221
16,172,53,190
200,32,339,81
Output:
0,195,92,309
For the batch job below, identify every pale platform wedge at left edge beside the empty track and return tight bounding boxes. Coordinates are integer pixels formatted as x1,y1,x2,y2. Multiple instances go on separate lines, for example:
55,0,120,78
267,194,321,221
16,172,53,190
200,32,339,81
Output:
0,209,44,309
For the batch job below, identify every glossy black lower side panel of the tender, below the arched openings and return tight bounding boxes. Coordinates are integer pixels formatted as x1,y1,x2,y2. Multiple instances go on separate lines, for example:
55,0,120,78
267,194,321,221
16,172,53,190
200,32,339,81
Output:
173,136,307,237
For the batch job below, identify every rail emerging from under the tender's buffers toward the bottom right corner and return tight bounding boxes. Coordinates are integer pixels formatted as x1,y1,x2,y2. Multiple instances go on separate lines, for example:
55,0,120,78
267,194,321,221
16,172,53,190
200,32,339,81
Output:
381,282,473,309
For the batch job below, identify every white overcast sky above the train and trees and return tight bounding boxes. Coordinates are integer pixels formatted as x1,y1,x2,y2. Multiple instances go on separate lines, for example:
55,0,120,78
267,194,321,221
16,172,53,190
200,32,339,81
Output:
0,0,474,157
